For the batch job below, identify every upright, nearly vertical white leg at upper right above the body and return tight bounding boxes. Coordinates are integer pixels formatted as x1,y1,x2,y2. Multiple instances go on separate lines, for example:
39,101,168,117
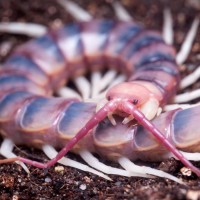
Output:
163,8,174,45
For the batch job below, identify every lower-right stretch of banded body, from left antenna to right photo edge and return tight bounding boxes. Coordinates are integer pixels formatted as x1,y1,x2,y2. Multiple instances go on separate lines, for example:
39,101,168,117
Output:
93,106,200,161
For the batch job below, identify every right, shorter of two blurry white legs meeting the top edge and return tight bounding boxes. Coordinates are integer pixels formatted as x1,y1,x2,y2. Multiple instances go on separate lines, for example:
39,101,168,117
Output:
112,1,133,21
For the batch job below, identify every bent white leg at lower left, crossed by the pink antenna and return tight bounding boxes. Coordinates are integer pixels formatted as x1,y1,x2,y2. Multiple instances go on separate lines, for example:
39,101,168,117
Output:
0,138,30,174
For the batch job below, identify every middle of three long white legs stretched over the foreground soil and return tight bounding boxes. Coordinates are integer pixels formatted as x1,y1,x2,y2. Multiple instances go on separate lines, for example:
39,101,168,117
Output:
79,150,148,177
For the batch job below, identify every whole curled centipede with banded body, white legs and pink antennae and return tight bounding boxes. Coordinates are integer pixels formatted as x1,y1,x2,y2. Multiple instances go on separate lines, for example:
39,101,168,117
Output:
0,0,200,184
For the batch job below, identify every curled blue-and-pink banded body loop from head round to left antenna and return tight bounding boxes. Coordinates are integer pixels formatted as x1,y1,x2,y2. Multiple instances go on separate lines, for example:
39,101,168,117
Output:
0,20,179,147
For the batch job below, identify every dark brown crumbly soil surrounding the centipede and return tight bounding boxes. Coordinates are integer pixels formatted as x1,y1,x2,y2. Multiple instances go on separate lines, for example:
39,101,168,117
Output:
0,0,200,200
